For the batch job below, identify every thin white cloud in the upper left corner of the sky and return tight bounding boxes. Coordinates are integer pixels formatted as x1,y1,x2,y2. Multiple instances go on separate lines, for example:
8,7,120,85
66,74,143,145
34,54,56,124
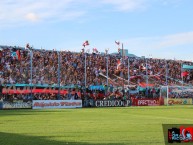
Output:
0,0,85,26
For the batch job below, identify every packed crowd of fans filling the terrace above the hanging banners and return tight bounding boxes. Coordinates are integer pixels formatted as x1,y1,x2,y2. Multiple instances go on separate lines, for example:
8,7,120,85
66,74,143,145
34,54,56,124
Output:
0,46,193,99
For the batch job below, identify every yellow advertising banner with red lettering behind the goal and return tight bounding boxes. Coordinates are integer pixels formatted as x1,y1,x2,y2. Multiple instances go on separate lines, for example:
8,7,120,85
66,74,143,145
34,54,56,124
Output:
164,98,192,105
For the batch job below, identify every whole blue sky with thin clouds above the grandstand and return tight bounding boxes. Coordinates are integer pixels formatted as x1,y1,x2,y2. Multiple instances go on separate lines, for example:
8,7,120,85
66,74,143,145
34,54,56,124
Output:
0,0,193,61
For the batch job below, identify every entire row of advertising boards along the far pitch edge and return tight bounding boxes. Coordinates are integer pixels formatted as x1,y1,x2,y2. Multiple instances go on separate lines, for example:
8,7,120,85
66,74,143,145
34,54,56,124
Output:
0,98,193,109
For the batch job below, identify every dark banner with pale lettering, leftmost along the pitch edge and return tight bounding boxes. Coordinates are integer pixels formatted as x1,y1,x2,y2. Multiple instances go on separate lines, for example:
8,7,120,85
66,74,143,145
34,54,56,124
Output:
2,101,32,109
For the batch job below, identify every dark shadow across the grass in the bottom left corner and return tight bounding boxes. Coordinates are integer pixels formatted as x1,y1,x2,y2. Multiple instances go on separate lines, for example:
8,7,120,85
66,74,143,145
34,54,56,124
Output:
0,132,123,145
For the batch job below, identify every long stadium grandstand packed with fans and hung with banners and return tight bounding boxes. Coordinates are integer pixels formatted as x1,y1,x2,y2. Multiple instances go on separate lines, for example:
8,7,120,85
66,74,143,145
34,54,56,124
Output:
0,44,193,100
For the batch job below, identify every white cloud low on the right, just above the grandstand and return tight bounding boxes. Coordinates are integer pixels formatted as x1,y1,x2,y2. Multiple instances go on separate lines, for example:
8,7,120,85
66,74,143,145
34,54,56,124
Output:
122,32,193,60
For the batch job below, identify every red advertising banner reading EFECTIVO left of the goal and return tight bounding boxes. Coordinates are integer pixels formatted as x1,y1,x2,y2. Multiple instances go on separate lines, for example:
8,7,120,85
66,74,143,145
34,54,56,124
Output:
132,99,160,106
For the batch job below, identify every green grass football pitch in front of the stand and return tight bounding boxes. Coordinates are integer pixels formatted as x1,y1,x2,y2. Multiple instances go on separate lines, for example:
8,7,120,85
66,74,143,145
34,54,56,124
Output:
0,106,193,145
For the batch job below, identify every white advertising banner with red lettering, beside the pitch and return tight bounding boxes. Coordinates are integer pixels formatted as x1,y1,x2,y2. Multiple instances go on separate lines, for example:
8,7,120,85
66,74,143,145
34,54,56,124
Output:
32,100,82,109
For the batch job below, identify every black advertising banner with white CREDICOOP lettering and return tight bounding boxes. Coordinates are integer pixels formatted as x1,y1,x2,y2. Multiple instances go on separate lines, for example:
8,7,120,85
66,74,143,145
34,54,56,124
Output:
95,100,131,107
